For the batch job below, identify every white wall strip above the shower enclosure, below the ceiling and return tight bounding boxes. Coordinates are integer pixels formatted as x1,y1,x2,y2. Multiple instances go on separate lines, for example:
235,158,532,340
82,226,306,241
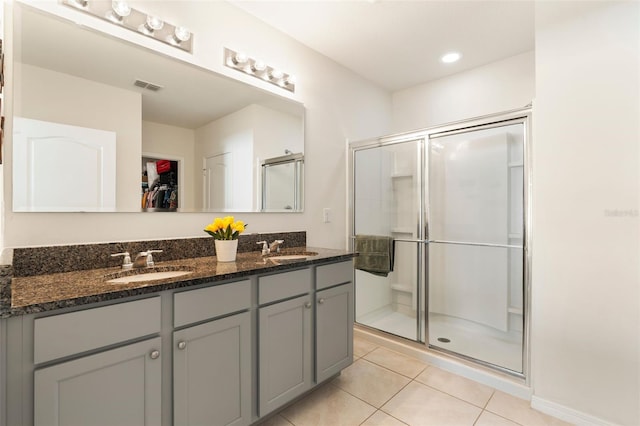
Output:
392,52,535,133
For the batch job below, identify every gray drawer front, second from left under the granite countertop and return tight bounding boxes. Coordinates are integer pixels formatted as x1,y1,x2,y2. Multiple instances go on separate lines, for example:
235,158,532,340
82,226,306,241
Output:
173,280,251,327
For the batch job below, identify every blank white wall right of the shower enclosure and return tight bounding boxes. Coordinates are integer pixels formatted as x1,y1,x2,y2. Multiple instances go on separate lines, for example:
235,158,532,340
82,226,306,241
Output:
531,2,640,425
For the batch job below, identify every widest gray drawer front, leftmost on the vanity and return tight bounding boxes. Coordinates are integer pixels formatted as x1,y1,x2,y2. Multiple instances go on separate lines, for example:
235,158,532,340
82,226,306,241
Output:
33,297,161,364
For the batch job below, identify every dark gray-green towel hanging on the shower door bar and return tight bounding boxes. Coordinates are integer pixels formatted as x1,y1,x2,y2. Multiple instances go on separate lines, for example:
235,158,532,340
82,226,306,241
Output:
354,235,394,277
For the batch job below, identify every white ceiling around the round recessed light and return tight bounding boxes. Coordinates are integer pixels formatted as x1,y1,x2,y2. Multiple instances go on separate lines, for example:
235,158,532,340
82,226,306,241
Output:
229,0,534,91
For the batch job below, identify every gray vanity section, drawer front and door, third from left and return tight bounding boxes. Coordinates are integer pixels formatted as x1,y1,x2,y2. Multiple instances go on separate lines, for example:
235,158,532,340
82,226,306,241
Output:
258,269,313,416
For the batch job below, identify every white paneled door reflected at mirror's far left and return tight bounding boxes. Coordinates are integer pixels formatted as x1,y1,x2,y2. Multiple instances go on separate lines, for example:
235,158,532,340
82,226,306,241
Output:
13,117,116,212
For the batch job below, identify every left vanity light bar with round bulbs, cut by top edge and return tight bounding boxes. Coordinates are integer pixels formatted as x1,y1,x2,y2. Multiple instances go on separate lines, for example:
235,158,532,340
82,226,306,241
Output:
62,0,193,53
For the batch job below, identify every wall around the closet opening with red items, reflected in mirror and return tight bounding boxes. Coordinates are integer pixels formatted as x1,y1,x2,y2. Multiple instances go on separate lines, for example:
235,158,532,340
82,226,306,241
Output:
142,121,195,209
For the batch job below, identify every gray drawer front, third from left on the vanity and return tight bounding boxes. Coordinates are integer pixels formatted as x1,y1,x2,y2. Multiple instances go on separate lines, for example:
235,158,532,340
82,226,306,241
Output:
258,269,311,305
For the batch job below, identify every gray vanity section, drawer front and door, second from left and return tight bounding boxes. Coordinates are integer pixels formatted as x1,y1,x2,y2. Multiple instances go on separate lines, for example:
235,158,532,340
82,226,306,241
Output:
173,280,252,426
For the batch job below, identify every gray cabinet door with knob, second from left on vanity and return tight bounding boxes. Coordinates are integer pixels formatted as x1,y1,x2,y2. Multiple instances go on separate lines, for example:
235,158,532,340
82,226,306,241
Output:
173,312,251,426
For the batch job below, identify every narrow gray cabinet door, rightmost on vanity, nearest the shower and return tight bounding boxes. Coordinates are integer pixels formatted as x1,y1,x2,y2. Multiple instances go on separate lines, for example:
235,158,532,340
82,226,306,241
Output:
316,283,353,383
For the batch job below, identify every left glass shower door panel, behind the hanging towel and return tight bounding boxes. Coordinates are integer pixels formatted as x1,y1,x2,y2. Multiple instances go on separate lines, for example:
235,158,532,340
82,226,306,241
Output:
352,139,424,341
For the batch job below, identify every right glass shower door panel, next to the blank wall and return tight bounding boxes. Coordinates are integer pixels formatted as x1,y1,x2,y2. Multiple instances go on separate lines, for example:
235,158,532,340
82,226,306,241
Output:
427,122,524,373
